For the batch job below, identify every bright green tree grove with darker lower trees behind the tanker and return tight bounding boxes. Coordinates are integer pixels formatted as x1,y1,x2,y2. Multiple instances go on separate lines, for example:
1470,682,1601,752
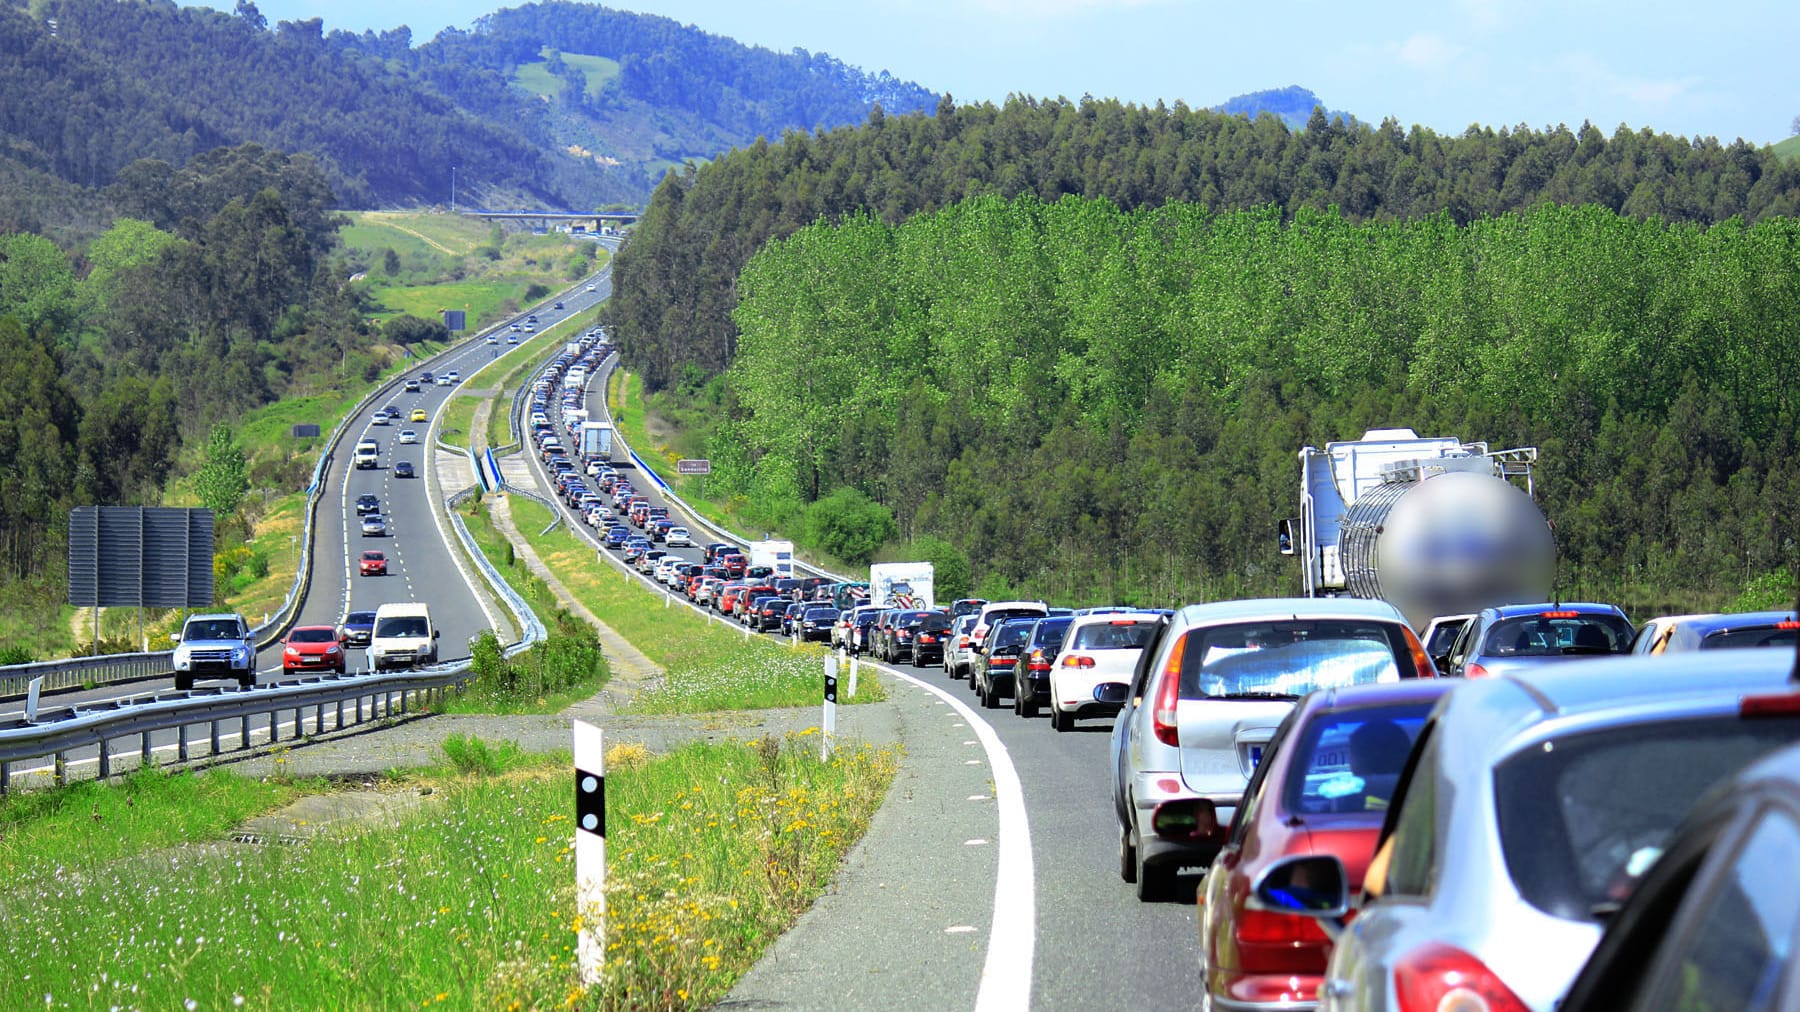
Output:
706,194,1800,610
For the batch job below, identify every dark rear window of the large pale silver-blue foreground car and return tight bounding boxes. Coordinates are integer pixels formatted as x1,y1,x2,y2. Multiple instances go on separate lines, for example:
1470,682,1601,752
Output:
1494,713,1800,920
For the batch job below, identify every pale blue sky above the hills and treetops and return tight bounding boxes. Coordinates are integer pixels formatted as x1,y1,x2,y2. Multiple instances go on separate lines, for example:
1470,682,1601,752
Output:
212,0,1800,144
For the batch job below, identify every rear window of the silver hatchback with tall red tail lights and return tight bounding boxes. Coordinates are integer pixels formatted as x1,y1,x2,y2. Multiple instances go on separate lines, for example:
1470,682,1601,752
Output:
1181,619,1413,699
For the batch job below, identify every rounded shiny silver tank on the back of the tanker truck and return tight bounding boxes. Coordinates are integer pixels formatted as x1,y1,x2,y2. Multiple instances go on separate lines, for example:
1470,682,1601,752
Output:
1339,472,1557,628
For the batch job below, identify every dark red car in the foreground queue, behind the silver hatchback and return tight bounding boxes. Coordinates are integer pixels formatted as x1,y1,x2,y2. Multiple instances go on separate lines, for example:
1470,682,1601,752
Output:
1154,679,1460,1012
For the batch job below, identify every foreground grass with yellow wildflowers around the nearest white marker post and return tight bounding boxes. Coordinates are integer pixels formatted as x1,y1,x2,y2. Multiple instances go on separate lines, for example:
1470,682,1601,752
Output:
0,727,896,1008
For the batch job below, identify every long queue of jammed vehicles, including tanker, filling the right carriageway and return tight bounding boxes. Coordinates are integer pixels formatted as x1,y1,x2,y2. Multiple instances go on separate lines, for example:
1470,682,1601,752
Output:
529,330,1800,1012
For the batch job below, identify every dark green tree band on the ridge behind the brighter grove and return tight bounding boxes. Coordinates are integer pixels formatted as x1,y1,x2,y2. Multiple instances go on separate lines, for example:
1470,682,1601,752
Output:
610,99,1800,389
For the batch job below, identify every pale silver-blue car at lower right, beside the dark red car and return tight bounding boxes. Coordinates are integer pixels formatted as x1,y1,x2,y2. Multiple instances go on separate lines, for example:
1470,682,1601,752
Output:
1255,650,1800,1012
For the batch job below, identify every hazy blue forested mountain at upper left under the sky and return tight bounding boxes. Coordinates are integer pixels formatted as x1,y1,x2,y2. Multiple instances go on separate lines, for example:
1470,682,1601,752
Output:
0,0,936,212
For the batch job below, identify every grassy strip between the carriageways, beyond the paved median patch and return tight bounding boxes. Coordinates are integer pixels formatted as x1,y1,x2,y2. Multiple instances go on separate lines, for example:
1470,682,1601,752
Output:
509,497,887,713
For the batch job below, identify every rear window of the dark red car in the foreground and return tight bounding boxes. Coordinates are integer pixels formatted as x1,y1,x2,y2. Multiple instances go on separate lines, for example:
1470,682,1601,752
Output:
1282,700,1436,814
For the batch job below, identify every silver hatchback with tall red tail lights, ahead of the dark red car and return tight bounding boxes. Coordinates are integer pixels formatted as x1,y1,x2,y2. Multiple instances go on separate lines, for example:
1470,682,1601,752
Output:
1094,598,1435,900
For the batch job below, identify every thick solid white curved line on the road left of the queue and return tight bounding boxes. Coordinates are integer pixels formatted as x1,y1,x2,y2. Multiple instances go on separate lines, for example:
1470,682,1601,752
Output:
873,664,1037,1012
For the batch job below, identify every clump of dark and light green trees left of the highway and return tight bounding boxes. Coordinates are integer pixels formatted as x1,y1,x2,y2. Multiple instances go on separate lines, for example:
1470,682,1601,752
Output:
0,144,382,583
